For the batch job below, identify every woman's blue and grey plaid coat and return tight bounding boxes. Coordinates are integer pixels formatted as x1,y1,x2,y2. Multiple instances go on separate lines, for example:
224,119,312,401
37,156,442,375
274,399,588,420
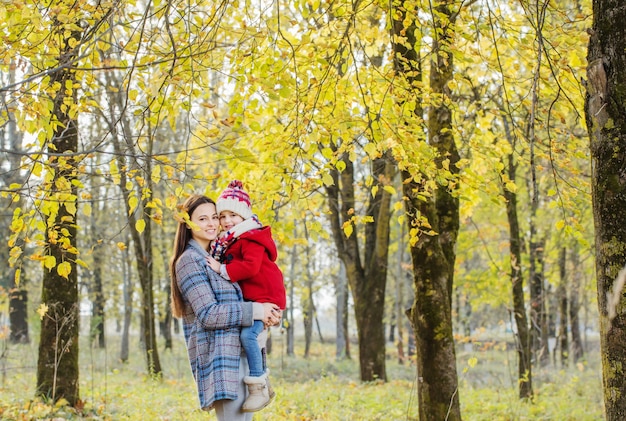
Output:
176,240,253,409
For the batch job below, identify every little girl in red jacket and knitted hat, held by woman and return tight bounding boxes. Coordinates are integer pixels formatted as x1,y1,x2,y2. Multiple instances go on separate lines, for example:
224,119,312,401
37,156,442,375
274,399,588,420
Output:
208,180,287,412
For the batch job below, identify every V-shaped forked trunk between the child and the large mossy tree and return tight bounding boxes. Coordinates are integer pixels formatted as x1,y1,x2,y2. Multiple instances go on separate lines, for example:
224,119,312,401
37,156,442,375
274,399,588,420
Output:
326,152,393,381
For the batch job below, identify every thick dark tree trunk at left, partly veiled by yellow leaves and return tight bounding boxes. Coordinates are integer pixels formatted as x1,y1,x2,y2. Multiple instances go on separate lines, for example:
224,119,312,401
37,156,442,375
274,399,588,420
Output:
36,22,79,406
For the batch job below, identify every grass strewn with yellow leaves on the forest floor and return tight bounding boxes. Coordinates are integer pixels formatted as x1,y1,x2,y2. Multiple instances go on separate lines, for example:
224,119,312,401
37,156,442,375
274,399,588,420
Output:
0,331,603,421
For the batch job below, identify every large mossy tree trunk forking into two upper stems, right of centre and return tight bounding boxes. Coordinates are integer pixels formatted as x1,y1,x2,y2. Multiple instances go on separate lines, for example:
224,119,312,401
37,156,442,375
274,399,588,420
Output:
392,1,461,421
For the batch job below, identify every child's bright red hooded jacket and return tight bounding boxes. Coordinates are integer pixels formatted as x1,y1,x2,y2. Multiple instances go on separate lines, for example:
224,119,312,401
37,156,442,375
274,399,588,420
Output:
223,226,287,310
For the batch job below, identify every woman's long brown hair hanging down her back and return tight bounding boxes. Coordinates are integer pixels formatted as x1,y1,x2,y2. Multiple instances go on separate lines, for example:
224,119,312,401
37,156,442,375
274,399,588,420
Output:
170,194,215,318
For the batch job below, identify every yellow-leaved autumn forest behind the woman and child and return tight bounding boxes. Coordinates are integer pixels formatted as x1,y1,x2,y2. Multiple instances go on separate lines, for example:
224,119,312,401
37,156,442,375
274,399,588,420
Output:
0,0,602,419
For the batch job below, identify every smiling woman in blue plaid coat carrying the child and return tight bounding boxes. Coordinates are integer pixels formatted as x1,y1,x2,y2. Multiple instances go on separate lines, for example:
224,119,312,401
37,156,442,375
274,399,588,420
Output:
170,195,281,421
